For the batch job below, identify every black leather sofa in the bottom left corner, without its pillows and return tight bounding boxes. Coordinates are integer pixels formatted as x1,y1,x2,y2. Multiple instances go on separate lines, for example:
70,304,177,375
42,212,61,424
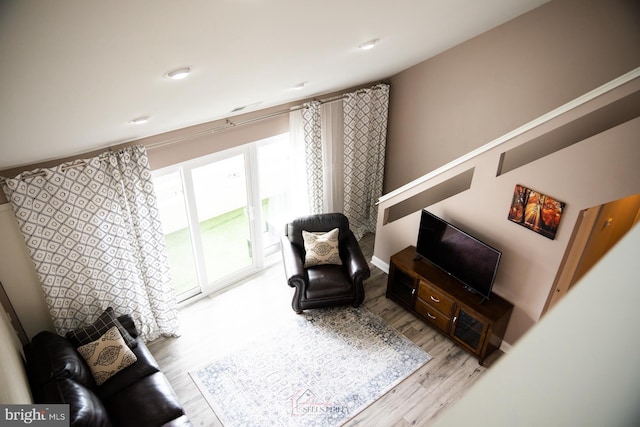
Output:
25,315,191,427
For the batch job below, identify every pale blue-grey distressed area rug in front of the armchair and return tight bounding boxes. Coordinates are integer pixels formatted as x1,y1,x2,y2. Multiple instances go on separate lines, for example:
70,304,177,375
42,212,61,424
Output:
189,307,431,427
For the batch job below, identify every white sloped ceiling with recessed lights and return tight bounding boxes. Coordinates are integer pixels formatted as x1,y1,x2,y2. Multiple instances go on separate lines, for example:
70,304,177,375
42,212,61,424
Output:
0,0,548,169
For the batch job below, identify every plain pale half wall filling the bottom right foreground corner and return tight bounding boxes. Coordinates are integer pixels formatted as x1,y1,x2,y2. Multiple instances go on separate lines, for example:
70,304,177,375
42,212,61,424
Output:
433,222,640,427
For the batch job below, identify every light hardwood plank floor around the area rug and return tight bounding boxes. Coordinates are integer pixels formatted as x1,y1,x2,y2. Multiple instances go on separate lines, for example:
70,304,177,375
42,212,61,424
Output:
149,235,499,426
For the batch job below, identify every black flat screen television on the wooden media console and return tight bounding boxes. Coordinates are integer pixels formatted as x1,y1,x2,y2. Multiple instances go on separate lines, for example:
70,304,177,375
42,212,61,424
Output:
416,209,502,298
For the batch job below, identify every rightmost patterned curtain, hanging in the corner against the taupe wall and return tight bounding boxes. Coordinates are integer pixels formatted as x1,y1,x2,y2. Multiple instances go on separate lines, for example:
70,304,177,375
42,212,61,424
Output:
343,84,389,239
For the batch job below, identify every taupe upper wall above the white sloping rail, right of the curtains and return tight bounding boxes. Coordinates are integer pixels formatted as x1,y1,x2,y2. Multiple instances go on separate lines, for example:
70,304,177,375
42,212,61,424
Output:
384,0,640,193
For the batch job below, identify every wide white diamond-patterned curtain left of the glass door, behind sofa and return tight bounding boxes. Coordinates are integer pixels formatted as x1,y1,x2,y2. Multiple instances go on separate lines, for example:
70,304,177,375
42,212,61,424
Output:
0,146,178,341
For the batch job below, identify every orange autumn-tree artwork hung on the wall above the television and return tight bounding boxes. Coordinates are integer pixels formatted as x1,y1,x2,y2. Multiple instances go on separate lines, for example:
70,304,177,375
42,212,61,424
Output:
508,185,565,240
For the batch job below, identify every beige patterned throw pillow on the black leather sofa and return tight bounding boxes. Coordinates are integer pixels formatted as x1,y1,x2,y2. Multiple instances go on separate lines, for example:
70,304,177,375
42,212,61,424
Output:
78,326,138,385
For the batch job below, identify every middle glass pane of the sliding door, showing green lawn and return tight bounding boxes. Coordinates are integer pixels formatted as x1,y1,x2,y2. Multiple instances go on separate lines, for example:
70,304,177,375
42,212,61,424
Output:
192,155,253,283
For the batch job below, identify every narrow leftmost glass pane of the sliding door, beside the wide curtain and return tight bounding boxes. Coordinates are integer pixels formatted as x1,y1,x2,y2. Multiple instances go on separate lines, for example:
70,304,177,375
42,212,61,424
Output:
153,172,199,295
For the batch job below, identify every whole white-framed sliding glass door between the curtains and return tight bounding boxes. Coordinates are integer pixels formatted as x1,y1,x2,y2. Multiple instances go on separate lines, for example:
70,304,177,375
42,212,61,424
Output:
154,134,290,300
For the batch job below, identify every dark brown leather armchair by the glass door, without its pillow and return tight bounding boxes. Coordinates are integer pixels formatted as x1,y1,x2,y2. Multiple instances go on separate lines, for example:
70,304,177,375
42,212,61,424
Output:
282,213,371,313
